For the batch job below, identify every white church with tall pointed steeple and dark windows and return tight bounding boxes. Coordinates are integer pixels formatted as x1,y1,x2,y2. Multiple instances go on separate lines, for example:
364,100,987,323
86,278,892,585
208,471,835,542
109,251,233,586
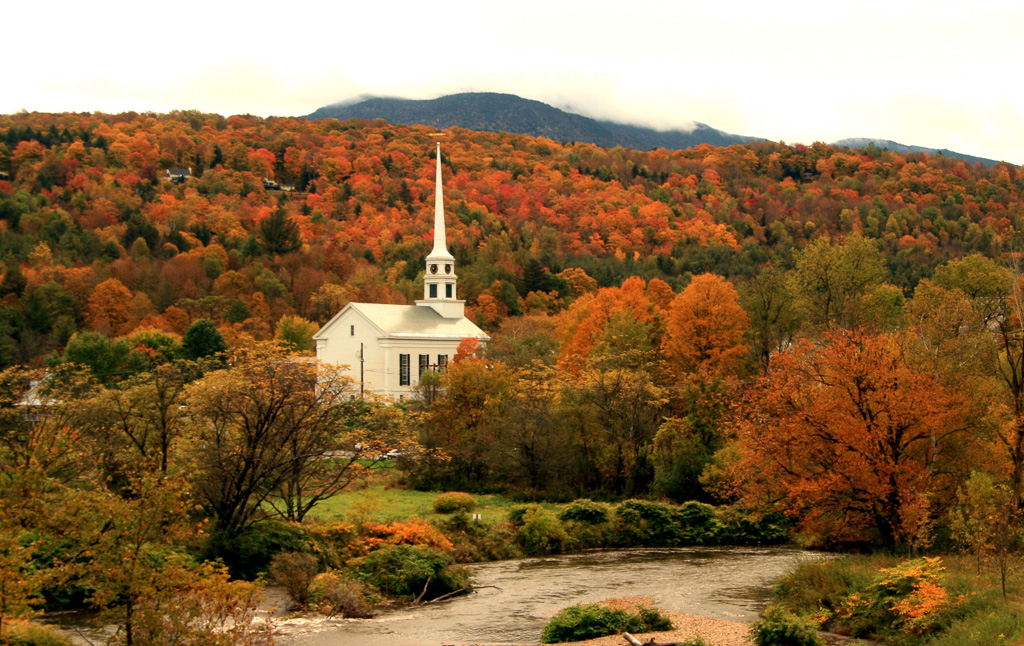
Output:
313,143,490,398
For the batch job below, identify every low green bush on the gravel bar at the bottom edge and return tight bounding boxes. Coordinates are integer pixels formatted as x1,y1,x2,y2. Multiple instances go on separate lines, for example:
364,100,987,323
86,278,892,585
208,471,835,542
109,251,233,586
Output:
541,603,674,644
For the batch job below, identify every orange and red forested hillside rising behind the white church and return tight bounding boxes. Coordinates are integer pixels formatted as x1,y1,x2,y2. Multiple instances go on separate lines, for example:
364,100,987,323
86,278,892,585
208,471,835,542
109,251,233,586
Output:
0,111,1022,364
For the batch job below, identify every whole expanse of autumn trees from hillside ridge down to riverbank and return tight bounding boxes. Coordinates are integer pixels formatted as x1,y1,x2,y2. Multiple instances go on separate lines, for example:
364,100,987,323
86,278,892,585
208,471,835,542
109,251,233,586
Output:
0,112,1024,643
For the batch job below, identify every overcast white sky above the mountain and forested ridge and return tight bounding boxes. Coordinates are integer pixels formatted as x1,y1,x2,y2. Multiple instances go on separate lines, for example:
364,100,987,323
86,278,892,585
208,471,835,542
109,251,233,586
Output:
8,0,1024,164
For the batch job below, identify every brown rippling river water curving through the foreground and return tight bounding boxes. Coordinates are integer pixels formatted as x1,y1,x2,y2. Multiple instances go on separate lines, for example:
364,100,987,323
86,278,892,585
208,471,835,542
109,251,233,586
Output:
281,548,821,646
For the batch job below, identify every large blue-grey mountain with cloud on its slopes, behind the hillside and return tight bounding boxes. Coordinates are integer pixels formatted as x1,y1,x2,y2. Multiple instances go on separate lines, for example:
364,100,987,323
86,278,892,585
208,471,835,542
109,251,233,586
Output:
306,92,760,150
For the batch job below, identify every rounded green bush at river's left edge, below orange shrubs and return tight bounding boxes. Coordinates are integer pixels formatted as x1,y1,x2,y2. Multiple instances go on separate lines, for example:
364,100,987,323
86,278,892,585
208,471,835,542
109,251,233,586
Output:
353,545,470,600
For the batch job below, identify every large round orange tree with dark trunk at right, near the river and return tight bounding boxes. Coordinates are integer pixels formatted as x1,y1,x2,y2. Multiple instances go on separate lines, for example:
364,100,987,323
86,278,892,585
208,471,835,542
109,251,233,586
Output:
736,331,965,547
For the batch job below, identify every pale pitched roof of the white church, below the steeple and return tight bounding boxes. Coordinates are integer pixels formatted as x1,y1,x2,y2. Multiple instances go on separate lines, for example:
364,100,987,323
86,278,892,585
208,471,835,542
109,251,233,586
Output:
313,303,490,340
